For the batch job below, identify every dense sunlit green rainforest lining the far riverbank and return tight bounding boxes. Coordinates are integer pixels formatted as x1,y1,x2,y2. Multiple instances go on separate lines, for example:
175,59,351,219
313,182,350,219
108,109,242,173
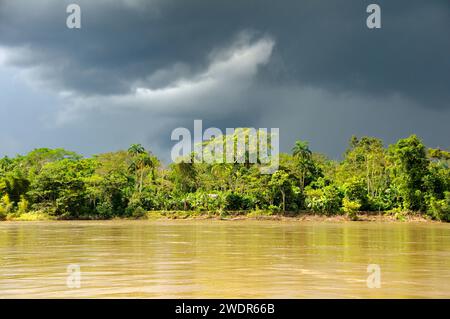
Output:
0,135,450,221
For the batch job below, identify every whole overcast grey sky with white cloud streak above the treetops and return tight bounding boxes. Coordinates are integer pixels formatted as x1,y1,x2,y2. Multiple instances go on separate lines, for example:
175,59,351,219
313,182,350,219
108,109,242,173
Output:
0,0,450,161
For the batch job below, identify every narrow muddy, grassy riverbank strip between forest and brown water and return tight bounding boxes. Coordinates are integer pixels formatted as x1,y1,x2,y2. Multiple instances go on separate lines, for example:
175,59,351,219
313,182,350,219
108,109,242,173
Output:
4,210,440,223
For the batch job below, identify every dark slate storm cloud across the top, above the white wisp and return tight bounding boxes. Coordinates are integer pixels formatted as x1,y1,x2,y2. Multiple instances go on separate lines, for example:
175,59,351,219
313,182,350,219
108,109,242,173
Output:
0,0,450,104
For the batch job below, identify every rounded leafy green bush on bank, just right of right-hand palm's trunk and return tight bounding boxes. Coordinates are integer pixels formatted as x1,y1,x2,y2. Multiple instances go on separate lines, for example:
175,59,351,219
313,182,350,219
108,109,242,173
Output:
306,185,342,214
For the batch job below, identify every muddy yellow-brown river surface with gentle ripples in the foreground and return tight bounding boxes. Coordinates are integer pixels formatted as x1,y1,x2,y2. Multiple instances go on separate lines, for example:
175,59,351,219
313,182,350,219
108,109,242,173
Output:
0,220,450,298
